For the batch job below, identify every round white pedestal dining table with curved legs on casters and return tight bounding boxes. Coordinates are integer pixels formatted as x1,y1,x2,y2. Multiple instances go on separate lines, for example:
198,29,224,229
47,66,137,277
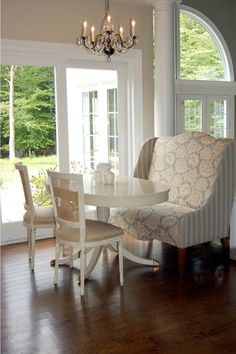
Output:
80,175,169,277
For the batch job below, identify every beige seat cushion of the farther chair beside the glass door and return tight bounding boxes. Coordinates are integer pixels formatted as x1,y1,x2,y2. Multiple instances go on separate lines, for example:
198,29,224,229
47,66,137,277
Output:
24,206,55,225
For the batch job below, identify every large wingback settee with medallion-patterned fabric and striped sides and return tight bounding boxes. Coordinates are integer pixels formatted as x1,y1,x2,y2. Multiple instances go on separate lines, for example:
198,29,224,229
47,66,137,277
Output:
109,132,236,276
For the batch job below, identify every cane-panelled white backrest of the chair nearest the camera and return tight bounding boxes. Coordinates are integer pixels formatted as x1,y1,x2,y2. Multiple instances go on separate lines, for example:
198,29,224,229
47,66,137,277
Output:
47,170,85,241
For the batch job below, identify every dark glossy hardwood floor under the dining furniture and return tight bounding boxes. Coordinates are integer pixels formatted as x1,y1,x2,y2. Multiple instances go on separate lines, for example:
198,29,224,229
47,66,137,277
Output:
1,235,236,354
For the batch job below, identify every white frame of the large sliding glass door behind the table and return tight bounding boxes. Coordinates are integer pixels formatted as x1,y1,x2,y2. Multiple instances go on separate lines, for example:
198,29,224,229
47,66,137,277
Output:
0,39,143,244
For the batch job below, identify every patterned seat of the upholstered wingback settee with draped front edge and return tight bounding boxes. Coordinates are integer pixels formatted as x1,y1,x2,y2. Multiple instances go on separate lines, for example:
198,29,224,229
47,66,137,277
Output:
109,202,196,246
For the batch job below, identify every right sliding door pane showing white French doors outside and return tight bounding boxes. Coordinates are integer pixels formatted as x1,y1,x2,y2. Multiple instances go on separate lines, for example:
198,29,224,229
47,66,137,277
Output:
67,68,119,173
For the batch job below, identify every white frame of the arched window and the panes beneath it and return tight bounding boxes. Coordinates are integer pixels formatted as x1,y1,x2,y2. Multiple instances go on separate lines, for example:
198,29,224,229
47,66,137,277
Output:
175,5,236,137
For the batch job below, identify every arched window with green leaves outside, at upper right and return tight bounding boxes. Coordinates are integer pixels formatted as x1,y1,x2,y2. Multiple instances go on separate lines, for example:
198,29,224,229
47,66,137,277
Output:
179,6,233,81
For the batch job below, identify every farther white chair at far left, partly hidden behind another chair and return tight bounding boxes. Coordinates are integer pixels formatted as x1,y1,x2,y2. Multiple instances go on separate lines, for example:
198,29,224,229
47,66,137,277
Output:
15,162,55,271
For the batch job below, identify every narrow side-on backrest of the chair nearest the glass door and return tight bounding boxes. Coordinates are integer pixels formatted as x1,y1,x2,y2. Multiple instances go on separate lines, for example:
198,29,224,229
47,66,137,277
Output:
15,162,34,213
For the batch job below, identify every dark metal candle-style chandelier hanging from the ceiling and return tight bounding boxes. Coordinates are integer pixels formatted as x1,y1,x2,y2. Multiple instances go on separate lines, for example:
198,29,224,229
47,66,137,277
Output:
76,0,138,62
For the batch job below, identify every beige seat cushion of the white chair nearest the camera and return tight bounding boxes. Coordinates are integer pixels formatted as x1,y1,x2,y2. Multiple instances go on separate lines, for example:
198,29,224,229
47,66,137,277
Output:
56,220,123,243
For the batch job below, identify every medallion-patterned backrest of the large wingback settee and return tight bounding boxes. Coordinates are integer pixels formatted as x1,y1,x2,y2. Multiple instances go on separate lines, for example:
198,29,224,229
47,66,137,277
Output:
148,132,235,209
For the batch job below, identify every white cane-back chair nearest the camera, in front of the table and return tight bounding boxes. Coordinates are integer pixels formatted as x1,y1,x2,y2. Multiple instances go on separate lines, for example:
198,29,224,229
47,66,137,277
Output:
47,170,124,296
